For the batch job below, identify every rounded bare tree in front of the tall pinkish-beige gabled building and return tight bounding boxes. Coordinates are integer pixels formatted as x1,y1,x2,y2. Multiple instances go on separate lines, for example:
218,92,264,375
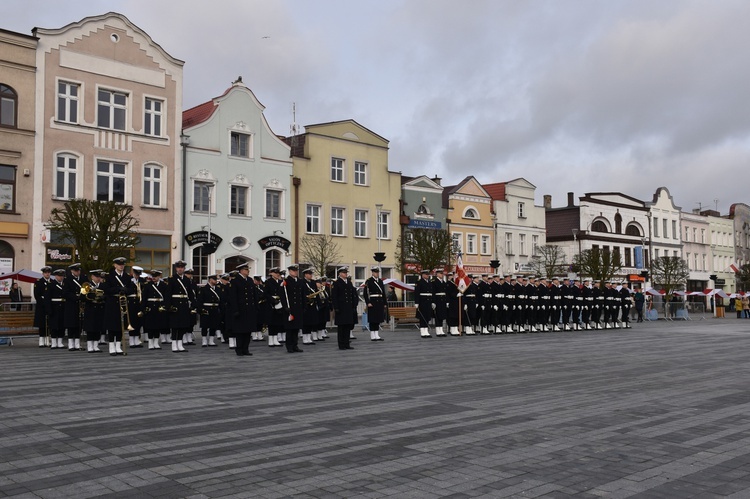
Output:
45,199,141,270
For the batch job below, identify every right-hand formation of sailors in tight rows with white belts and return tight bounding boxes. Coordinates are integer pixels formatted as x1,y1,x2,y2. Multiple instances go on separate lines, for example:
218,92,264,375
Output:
414,270,633,338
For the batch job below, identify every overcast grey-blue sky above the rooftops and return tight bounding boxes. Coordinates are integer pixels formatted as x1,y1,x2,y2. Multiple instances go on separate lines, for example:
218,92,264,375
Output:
5,0,750,214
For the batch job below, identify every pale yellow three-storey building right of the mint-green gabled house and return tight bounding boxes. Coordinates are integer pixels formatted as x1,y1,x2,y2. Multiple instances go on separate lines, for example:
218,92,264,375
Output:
286,120,401,284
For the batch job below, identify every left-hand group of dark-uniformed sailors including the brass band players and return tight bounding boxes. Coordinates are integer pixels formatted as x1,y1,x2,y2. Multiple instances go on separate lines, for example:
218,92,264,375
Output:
34,257,376,356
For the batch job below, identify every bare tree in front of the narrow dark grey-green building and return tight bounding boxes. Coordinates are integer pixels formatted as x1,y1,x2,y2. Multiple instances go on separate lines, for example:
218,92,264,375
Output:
396,229,458,273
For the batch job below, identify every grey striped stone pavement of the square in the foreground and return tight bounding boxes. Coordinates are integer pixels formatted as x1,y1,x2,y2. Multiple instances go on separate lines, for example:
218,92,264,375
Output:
0,319,750,498
